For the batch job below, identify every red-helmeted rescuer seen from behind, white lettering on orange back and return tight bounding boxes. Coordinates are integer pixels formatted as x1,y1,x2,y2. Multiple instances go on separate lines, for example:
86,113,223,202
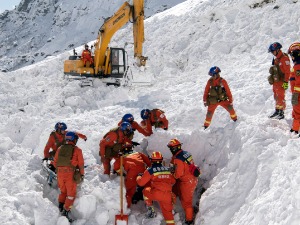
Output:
137,152,175,225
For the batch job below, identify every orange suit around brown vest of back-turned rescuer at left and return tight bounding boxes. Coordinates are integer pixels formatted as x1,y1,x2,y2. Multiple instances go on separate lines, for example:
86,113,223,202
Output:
54,143,84,211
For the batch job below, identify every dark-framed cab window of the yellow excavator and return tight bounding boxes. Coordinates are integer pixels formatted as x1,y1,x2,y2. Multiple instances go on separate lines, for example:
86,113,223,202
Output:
110,48,125,76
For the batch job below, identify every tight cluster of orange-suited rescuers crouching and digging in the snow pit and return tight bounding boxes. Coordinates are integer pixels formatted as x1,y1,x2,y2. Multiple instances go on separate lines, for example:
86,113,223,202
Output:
99,109,200,225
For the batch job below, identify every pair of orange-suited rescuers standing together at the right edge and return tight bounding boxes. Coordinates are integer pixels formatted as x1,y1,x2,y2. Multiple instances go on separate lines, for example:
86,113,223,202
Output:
268,42,300,135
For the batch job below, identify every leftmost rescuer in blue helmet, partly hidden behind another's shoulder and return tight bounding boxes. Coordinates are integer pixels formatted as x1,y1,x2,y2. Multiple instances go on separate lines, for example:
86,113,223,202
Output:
43,122,87,171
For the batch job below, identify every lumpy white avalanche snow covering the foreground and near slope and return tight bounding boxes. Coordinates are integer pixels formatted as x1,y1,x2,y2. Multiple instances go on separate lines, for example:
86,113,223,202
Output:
0,0,300,225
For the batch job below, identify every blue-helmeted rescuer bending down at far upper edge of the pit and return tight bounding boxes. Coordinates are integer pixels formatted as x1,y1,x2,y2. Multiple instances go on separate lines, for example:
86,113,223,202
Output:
141,109,169,136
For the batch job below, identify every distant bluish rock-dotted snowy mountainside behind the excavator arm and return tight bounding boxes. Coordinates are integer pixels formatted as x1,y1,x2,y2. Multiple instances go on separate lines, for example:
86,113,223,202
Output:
0,0,185,71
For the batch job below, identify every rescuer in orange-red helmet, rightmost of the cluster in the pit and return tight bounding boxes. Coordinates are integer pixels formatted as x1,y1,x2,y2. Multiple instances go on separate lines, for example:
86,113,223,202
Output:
167,139,198,225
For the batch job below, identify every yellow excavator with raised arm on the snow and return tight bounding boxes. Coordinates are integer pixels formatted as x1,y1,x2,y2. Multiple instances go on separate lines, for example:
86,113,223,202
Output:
64,0,147,84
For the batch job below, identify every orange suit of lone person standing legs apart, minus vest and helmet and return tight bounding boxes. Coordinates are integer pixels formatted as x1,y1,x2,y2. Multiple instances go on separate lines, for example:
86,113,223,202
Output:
203,75,237,127
